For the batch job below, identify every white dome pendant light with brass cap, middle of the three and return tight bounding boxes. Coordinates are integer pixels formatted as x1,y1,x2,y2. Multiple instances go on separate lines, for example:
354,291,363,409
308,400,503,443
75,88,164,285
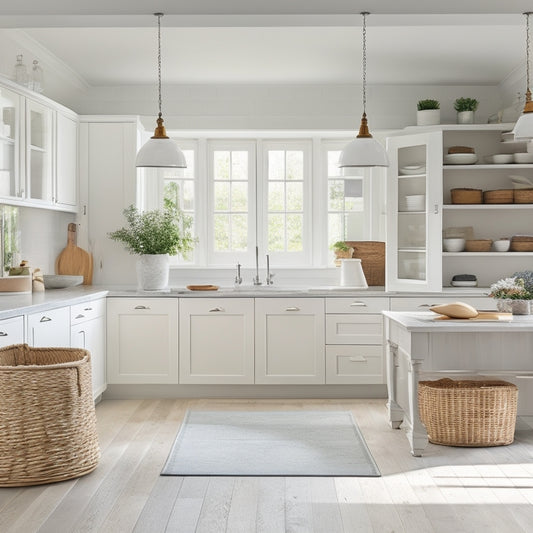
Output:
339,11,389,168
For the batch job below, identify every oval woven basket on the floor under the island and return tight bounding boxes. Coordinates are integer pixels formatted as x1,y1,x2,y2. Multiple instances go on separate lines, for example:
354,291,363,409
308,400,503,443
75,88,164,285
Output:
418,378,518,447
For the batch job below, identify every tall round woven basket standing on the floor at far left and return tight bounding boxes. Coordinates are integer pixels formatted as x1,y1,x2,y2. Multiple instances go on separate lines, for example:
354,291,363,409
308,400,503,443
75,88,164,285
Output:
0,344,100,487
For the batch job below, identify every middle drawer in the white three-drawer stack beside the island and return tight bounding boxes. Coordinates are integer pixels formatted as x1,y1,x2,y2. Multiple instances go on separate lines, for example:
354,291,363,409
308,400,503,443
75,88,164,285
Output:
326,314,383,344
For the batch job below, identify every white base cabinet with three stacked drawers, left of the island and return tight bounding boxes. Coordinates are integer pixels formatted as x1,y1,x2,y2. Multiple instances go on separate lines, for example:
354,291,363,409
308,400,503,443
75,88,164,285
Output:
326,297,389,384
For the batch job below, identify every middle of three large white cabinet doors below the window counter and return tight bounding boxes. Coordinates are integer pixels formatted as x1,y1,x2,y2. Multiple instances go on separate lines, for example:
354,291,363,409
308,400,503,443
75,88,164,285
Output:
179,298,254,384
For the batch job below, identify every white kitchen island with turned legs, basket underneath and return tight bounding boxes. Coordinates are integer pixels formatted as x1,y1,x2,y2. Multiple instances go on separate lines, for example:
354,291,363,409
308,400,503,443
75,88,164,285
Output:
383,311,533,457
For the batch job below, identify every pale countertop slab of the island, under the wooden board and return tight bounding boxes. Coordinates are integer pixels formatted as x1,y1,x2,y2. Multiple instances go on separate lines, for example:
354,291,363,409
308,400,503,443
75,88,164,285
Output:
383,311,533,333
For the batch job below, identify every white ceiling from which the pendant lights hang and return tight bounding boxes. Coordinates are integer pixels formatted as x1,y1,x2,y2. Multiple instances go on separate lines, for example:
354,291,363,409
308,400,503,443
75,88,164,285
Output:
0,0,531,86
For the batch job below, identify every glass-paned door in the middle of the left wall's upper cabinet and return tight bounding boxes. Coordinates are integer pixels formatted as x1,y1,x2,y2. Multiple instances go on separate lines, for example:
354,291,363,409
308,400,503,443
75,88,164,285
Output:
26,99,53,203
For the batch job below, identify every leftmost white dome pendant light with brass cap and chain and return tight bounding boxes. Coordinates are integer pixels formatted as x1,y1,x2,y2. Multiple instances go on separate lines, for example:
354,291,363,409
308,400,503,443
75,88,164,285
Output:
135,13,187,168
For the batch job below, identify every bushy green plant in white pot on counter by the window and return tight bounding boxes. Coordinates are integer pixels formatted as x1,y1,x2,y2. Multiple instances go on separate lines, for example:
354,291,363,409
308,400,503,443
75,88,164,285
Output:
109,205,196,291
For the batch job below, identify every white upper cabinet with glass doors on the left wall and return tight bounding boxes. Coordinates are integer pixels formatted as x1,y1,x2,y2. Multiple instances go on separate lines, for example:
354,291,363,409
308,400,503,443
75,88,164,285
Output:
0,79,78,212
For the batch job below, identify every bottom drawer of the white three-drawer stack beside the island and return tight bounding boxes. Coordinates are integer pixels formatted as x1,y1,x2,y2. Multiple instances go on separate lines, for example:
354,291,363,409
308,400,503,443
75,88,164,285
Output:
326,346,383,384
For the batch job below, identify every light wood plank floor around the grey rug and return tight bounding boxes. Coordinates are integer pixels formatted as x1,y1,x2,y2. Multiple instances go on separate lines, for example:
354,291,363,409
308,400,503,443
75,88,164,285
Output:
0,399,533,533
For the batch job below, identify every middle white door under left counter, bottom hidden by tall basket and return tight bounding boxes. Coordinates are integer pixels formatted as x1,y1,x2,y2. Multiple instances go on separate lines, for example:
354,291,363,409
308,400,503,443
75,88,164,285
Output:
27,307,70,348
